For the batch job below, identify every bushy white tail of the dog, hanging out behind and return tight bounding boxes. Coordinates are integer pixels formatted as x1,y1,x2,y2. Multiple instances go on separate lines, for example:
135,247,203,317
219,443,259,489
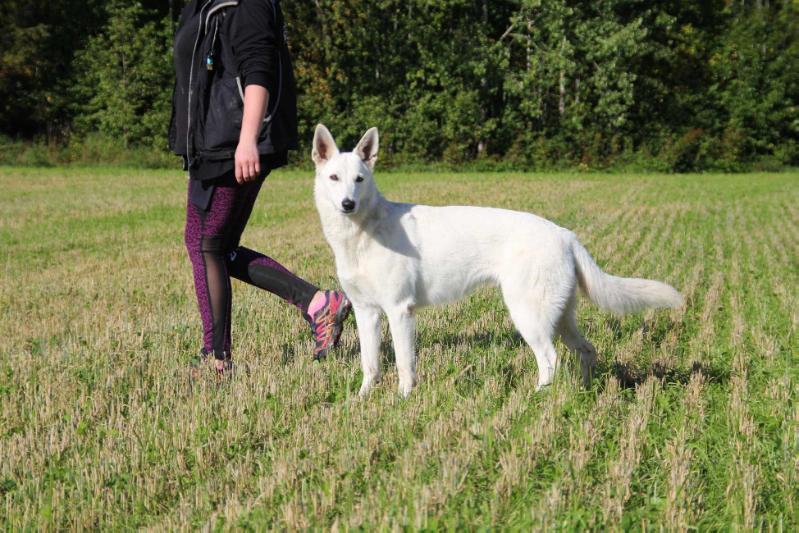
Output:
572,238,683,315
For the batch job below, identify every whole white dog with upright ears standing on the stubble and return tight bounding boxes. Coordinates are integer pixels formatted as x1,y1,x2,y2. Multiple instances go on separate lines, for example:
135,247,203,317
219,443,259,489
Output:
312,124,682,396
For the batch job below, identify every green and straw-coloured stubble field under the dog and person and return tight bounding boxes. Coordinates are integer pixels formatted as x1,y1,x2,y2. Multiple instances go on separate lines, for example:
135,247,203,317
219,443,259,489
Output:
0,168,799,531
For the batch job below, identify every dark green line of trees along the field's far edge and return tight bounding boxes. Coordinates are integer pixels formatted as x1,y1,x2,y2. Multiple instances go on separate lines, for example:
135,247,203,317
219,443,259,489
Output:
0,0,799,171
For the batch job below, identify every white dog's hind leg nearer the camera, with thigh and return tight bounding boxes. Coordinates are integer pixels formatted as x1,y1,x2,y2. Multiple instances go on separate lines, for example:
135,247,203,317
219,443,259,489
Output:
502,286,561,390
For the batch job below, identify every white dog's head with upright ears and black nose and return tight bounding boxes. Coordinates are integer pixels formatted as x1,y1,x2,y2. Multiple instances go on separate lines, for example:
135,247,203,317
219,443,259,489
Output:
311,124,378,216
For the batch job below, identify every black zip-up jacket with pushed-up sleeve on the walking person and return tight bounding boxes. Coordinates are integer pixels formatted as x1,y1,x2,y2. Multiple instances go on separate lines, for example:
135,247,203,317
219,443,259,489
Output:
169,0,297,168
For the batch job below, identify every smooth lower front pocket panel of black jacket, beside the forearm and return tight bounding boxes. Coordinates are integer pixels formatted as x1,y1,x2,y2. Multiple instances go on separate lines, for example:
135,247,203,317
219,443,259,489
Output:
201,76,244,152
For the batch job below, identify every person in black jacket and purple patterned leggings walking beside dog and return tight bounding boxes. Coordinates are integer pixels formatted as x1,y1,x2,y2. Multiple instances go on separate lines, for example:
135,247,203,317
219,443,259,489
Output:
169,0,351,375
